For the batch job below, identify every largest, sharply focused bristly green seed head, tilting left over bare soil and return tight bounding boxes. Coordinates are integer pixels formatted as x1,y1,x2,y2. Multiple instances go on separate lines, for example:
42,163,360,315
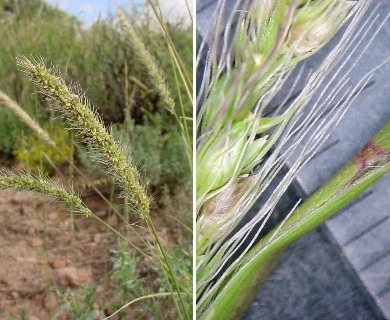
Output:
18,57,149,219
